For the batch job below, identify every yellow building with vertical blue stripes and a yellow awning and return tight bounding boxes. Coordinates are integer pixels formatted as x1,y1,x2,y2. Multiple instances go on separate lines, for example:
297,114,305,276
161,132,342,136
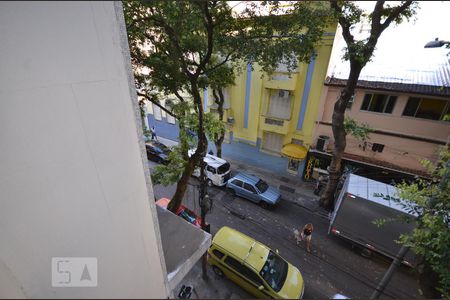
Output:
203,26,336,174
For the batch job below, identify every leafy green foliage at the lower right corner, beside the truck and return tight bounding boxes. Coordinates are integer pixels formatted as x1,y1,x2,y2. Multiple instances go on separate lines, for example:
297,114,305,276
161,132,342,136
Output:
397,147,450,299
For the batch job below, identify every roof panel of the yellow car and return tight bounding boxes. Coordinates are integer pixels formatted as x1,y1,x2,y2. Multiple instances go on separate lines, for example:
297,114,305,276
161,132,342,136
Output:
213,226,270,272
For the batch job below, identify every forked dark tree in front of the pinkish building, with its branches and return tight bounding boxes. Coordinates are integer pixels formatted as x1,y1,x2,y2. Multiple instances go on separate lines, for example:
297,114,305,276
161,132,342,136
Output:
319,0,417,210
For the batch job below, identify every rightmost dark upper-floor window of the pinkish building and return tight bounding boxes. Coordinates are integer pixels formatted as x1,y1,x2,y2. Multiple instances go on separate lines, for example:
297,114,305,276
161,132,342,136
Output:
403,97,450,120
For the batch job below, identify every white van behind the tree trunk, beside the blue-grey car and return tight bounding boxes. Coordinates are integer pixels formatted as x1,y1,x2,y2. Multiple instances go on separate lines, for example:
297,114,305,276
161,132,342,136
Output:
189,150,231,186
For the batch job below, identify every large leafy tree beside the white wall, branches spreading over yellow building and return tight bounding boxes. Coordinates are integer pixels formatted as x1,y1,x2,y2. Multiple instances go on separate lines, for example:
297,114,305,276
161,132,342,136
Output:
124,1,331,211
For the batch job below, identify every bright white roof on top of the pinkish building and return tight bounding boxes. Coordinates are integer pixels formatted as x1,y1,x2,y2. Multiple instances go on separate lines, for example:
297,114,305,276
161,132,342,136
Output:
325,49,450,96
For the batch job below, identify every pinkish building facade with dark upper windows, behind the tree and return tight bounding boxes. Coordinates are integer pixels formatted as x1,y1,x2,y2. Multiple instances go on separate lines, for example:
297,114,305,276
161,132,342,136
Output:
313,75,450,175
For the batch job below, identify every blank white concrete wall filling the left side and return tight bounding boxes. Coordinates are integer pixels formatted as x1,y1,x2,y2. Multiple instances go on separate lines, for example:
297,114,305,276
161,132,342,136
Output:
0,1,168,298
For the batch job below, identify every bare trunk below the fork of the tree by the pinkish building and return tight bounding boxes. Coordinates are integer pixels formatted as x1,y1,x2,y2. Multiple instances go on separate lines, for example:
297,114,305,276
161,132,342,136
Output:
319,63,362,211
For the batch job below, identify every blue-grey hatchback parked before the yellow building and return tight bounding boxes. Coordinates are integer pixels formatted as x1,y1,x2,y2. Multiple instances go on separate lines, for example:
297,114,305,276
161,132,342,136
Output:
227,173,281,209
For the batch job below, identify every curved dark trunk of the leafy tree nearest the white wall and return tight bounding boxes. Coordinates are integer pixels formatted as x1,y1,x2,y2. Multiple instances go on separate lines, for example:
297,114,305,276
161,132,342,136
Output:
167,82,207,213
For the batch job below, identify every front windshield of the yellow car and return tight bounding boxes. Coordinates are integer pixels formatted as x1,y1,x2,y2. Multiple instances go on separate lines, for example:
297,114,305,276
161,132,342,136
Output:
259,250,288,292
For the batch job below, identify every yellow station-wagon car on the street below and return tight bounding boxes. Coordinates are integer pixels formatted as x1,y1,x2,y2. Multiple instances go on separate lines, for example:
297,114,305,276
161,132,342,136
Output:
208,226,305,299
